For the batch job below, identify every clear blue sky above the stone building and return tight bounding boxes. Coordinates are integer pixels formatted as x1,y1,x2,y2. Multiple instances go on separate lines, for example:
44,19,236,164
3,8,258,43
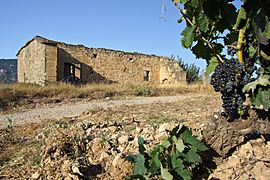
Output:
0,0,208,69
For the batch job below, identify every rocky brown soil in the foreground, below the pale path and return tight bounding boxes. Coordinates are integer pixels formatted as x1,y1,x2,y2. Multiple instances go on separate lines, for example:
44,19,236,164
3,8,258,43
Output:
0,94,270,179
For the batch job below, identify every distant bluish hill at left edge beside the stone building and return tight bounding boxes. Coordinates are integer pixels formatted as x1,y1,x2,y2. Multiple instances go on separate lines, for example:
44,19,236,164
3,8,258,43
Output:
0,59,17,83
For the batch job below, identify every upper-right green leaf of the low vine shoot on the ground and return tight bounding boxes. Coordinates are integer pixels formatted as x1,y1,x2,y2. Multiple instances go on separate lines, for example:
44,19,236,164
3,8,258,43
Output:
181,129,208,151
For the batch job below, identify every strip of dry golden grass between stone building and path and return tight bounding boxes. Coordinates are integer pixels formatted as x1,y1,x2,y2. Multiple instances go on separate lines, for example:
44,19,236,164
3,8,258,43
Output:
0,83,213,111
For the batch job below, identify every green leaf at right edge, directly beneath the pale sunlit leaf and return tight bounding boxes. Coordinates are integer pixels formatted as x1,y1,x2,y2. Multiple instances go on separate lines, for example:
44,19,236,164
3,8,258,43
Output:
250,86,270,111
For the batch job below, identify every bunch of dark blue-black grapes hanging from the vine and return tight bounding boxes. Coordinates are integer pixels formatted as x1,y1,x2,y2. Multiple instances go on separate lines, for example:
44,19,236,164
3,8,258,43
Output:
210,59,250,121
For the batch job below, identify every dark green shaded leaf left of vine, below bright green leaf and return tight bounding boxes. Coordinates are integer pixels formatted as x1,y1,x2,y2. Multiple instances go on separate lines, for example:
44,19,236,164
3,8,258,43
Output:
191,41,212,61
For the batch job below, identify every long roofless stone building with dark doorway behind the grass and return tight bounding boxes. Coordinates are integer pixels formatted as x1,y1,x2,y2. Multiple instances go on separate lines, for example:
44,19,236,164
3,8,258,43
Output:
17,36,186,85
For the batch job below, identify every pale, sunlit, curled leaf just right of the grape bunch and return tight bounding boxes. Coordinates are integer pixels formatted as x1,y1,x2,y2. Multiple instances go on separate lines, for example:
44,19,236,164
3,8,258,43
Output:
242,74,270,93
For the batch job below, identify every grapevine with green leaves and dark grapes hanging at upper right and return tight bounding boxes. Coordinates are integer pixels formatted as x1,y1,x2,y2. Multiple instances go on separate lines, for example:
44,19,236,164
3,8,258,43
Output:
173,0,270,121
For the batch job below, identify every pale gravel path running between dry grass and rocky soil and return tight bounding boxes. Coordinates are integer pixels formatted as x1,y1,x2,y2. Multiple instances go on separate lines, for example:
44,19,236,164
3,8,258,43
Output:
0,94,209,127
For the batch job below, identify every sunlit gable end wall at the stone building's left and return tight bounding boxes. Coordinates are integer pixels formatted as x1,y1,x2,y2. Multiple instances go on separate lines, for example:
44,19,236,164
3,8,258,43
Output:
17,40,46,85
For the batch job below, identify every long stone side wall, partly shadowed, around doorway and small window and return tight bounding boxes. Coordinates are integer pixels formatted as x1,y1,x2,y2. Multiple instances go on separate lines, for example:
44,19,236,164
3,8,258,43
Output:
58,43,160,83
